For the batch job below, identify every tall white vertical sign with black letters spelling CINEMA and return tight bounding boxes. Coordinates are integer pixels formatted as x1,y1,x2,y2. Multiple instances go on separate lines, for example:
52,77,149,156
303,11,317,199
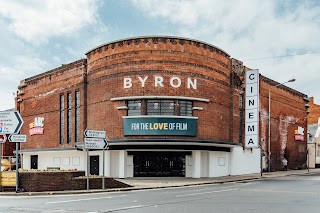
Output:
245,70,259,148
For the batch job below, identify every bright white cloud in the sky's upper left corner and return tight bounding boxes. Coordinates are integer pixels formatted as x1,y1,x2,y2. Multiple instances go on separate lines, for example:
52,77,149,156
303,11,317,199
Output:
0,0,98,43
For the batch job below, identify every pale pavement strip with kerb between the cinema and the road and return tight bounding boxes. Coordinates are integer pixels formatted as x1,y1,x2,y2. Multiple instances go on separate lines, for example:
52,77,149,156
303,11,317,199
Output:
0,169,320,196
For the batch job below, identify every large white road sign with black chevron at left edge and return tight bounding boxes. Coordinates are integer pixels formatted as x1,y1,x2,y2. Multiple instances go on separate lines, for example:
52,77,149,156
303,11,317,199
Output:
0,111,23,134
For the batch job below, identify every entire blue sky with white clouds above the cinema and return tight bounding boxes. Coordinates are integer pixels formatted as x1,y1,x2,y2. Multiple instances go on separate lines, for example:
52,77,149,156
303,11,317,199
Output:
0,0,320,111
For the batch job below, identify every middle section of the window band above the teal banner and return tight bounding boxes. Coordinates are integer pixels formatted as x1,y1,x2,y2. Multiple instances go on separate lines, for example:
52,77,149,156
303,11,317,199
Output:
147,100,174,115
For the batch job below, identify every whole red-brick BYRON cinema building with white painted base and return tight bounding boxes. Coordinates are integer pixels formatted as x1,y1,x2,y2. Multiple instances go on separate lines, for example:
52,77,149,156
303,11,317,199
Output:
16,36,307,178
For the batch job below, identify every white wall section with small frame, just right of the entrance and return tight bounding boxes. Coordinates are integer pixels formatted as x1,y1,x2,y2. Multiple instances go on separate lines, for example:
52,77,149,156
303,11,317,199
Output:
208,151,230,177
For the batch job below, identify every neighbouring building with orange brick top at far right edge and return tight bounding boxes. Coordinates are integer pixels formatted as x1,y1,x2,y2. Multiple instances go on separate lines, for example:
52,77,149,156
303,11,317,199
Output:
308,97,320,168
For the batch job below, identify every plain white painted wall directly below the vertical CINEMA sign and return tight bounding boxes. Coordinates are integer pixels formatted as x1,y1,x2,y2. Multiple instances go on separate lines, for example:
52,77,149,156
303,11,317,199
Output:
230,147,260,175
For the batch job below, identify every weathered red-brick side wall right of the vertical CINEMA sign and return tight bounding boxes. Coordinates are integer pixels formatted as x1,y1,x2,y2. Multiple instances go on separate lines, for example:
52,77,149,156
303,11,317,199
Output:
260,77,307,170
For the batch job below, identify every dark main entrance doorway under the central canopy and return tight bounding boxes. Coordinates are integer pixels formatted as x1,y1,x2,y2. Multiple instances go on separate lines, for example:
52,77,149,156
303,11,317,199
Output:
128,152,191,177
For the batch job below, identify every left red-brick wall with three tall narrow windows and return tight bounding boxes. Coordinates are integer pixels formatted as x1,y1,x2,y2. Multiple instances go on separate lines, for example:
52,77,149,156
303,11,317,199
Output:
19,60,86,149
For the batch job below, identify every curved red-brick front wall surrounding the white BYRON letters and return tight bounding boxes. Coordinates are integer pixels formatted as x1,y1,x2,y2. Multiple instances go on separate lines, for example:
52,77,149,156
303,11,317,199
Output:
87,37,238,141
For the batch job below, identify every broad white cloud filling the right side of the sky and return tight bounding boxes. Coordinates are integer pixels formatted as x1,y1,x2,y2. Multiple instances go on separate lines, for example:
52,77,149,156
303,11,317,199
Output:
132,0,320,100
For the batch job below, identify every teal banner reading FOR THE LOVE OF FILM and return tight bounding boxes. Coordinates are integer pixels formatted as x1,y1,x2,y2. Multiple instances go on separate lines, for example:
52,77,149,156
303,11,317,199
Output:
123,117,198,136
